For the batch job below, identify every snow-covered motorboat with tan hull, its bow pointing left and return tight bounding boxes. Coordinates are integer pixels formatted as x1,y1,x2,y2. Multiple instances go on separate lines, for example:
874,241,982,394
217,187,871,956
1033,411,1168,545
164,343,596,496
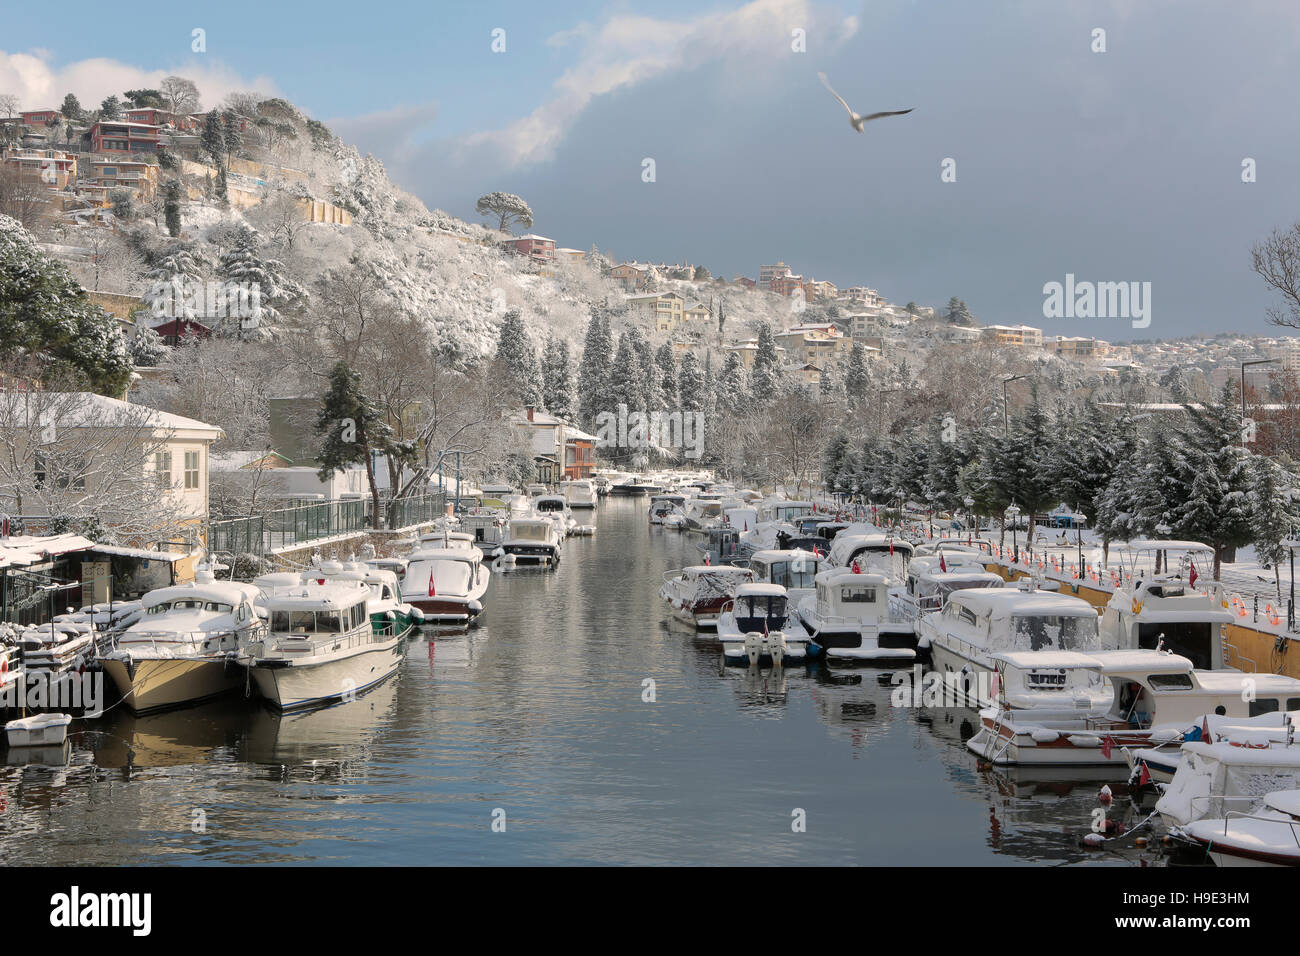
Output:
100,570,261,714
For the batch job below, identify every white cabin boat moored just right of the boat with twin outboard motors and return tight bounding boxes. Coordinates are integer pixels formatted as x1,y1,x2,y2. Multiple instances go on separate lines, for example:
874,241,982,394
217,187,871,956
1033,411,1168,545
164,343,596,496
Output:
796,567,917,662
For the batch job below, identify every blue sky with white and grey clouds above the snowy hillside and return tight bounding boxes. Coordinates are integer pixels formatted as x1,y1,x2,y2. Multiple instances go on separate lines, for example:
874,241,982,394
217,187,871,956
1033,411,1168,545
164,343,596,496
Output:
0,0,1300,341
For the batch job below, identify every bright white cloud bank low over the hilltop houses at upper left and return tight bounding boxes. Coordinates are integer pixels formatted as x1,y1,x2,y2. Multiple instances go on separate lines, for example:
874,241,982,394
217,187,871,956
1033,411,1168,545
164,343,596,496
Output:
0,49,277,109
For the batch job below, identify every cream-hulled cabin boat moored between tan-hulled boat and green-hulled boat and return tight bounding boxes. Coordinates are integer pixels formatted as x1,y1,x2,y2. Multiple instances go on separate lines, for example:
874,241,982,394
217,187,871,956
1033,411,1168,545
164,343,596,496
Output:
241,581,411,710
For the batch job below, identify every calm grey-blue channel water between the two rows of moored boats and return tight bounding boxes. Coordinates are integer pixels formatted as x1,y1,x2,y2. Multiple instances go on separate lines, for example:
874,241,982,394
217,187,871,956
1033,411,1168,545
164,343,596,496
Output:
0,499,1164,865
